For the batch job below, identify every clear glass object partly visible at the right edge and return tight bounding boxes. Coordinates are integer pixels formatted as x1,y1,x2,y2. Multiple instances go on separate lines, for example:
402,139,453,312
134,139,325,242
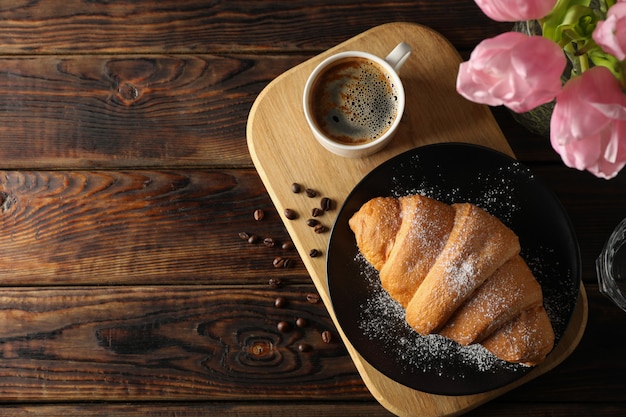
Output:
596,219,626,311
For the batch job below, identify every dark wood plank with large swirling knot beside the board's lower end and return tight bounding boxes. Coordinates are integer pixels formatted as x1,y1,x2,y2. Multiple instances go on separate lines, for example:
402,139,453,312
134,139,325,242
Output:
0,286,371,402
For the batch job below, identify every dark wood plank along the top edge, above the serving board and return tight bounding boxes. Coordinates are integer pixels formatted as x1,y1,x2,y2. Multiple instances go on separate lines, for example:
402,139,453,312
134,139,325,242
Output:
0,0,510,54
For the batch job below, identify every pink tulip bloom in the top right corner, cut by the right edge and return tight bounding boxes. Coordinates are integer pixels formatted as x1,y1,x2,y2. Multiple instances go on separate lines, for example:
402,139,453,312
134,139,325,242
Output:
592,2,626,60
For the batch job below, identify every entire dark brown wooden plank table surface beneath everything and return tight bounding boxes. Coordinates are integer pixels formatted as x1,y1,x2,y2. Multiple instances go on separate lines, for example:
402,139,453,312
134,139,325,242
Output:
0,0,626,417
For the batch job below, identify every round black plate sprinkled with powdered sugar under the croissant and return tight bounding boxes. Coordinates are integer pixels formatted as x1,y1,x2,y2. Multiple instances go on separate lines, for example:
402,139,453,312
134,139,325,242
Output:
327,143,581,395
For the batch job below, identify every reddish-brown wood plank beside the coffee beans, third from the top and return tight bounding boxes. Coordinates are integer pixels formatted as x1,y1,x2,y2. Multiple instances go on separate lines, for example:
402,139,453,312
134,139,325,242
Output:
0,170,314,285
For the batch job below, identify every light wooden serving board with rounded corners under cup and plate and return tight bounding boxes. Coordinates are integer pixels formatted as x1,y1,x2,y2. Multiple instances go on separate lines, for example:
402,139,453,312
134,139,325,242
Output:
247,23,587,416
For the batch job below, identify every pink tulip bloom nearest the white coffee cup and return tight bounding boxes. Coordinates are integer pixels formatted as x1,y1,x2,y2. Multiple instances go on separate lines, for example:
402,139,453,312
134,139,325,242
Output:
456,32,566,113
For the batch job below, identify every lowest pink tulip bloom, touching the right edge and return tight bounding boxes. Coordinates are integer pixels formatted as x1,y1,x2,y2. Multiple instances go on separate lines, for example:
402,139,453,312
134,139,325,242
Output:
550,67,626,179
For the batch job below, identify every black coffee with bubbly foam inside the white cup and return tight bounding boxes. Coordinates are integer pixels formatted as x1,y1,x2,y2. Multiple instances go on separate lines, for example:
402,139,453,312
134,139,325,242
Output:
310,57,398,145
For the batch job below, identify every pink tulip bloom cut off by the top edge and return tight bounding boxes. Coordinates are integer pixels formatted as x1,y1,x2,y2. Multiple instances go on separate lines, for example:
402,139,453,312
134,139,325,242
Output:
475,0,557,22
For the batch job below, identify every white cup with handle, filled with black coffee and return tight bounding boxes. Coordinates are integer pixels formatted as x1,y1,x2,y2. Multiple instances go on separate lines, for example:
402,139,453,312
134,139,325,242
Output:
303,42,411,158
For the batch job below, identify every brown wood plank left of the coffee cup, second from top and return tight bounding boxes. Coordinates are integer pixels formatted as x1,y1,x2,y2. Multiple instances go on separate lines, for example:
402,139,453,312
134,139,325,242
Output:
0,55,307,169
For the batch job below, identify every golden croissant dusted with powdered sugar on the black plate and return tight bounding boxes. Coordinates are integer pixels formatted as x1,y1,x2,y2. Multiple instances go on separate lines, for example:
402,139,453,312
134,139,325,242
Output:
349,194,554,365
